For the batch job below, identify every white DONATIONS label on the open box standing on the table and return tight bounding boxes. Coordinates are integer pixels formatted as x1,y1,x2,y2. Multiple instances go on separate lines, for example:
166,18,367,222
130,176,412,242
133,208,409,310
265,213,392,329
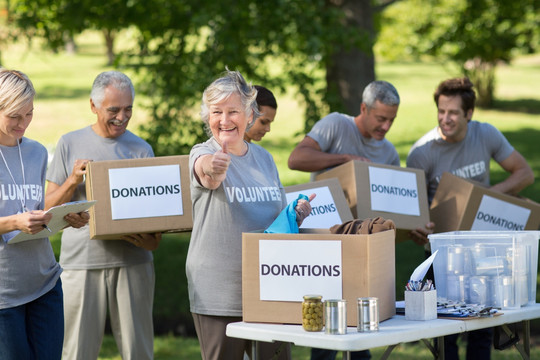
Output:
259,240,343,301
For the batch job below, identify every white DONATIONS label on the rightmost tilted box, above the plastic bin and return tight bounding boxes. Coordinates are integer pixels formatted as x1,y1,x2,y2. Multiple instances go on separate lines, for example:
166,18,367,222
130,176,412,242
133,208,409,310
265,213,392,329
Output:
471,195,531,231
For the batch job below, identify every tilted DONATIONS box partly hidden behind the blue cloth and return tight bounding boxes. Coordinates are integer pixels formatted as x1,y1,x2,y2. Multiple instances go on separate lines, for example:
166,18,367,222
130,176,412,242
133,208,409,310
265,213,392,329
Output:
285,178,353,229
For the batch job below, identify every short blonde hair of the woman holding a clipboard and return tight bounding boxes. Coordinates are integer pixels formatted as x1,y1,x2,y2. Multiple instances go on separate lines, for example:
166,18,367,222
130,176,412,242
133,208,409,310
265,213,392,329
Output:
0,69,36,114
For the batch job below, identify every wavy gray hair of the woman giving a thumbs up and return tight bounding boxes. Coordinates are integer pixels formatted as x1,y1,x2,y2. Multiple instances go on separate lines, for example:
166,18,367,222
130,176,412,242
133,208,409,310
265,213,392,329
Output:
201,69,261,136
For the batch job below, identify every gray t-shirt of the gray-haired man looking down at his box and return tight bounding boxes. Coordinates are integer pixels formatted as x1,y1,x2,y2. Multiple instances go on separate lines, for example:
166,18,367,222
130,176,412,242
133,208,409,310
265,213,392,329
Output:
307,112,400,180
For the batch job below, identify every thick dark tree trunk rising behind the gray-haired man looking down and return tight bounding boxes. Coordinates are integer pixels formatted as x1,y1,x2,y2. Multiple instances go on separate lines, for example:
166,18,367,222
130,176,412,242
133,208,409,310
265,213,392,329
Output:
326,0,375,116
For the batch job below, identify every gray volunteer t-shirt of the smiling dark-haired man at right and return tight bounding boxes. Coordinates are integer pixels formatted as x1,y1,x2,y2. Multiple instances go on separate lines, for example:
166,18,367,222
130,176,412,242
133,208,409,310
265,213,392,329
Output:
407,121,514,204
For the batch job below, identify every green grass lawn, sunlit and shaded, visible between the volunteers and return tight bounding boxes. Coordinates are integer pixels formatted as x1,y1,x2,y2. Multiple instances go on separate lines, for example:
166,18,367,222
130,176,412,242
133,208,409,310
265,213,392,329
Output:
2,32,540,360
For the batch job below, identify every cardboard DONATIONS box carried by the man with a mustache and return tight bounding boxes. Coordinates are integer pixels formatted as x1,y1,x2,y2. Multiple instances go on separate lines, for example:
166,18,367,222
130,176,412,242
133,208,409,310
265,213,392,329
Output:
86,155,193,240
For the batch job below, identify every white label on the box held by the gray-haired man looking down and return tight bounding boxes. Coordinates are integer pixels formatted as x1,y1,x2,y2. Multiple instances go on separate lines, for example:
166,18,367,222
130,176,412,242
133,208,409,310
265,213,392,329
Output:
370,166,420,216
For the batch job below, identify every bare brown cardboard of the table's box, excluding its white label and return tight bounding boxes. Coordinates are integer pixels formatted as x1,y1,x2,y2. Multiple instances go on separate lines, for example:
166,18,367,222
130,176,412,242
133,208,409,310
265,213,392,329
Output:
242,230,396,326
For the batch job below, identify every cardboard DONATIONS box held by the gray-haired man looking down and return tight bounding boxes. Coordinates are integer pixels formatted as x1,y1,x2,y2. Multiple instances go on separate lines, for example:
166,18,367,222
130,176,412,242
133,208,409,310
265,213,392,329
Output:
316,160,429,241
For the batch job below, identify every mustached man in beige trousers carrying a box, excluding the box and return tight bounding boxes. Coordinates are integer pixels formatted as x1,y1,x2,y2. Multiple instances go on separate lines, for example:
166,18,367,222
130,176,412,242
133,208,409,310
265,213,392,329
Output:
45,71,161,359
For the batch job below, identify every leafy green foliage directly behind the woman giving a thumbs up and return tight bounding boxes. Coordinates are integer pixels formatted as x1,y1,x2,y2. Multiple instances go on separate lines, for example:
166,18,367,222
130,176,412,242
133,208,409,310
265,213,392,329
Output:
120,0,368,155
